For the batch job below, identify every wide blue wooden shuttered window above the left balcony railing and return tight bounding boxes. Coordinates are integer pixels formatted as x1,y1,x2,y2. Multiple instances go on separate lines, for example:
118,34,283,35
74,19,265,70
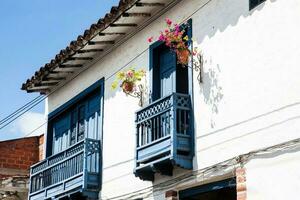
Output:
46,81,103,157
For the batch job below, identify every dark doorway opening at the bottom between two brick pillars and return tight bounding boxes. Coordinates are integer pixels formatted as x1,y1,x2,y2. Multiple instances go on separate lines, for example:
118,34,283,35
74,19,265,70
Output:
179,178,237,200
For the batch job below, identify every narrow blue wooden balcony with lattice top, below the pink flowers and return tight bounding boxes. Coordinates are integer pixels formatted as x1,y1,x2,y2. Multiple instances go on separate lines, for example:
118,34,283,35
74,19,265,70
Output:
134,93,194,181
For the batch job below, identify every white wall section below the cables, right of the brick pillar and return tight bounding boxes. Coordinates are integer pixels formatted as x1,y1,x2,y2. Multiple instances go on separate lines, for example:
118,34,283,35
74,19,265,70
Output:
245,148,300,200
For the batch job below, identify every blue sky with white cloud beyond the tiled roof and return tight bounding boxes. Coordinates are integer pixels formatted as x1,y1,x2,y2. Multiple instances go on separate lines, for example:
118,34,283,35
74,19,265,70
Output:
0,0,118,140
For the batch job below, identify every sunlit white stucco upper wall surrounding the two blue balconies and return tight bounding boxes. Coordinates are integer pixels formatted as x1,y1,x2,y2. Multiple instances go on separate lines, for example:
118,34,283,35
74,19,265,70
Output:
48,0,300,199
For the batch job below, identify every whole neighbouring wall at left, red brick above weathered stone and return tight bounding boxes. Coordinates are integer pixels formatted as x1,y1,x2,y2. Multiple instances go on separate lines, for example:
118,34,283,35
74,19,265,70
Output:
0,135,44,200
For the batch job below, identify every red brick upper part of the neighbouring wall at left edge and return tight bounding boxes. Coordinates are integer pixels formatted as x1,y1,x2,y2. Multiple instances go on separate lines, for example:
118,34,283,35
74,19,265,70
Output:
0,136,44,170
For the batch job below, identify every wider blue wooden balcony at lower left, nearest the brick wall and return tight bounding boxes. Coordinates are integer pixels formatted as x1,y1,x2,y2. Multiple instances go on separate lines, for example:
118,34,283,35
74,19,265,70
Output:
28,138,101,200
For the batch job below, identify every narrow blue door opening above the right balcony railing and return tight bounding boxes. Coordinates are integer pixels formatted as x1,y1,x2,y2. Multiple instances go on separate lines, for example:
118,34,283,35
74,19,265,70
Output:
150,20,192,101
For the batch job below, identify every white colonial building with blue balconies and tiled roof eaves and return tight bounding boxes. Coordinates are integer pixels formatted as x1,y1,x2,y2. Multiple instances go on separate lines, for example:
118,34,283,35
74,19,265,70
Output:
22,0,300,200
